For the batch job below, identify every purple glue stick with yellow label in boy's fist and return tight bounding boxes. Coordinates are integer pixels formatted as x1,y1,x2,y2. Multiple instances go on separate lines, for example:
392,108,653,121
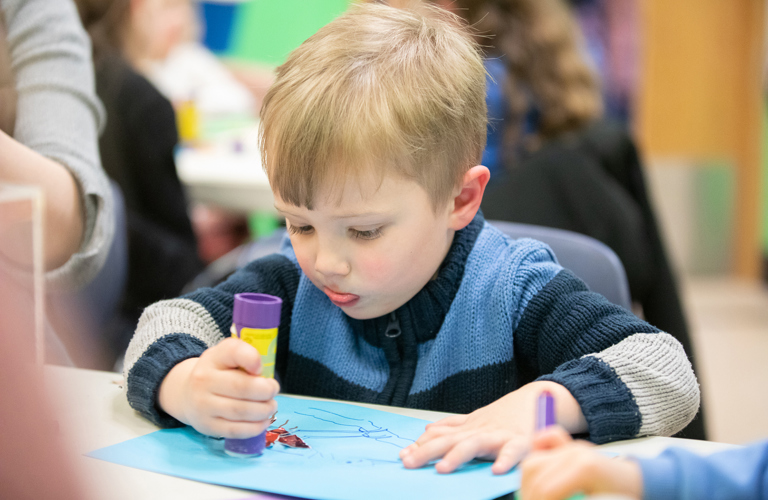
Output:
224,293,283,457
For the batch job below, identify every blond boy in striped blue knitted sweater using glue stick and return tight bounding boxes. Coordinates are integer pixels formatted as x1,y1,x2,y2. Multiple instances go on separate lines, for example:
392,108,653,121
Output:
125,0,699,473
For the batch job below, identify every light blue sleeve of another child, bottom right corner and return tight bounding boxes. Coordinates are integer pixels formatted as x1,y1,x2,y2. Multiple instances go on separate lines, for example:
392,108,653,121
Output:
637,441,768,500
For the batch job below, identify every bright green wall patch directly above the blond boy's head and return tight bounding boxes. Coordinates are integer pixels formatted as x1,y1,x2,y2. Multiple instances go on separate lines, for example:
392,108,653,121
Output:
226,0,350,65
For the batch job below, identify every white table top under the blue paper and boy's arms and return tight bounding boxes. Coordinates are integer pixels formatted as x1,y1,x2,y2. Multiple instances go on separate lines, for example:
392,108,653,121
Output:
45,366,733,500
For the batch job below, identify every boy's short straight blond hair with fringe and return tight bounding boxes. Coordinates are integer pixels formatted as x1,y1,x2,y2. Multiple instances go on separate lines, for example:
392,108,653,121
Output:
261,0,487,209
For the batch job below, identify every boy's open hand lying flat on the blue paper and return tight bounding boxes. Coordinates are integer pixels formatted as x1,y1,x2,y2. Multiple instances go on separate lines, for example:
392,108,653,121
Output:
400,382,586,474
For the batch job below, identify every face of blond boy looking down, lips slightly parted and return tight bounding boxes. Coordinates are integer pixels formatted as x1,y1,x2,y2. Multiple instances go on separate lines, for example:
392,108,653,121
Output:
275,176,454,319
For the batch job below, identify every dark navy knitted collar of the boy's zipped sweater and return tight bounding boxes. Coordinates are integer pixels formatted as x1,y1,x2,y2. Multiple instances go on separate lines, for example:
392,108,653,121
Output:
347,210,485,347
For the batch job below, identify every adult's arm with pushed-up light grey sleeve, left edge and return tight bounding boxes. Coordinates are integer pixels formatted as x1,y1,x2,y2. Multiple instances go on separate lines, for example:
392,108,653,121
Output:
0,0,114,289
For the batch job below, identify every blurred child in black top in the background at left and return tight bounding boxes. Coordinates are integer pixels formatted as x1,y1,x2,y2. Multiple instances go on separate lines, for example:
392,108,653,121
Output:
77,0,202,368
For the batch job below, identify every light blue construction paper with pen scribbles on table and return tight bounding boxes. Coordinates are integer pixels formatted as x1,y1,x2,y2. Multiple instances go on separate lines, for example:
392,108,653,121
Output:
88,396,520,500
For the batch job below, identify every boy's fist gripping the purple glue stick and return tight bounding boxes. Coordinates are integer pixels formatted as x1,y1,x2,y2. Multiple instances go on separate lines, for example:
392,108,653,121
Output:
159,338,280,439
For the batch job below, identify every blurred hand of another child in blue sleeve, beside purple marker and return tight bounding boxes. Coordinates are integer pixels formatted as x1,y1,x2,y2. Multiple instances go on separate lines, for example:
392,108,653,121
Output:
518,426,643,500
